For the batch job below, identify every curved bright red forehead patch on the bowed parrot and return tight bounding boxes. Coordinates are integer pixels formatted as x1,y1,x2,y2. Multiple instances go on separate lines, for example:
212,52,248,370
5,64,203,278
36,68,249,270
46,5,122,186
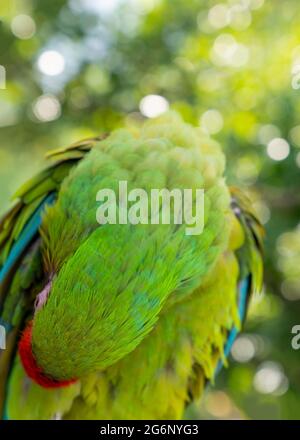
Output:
19,321,77,388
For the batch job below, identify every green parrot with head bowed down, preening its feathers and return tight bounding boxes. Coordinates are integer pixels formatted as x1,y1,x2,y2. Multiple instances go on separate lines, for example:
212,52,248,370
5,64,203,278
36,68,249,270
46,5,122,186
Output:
0,113,263,420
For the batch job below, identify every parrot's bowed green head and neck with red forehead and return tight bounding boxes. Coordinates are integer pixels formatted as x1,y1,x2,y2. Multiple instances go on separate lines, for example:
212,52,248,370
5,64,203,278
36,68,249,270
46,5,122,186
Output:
19,112,229,387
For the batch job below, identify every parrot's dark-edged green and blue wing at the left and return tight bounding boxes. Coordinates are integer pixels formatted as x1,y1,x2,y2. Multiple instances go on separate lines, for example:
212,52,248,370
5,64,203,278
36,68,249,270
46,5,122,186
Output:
0,136,104,415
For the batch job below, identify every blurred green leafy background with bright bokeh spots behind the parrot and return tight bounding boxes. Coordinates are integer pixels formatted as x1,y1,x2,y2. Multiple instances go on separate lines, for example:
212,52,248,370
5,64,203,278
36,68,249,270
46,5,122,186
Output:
0,0,300,419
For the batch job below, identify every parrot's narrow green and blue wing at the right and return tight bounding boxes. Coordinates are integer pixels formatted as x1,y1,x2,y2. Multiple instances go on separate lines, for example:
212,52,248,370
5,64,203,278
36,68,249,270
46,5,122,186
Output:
216,187,264,374
